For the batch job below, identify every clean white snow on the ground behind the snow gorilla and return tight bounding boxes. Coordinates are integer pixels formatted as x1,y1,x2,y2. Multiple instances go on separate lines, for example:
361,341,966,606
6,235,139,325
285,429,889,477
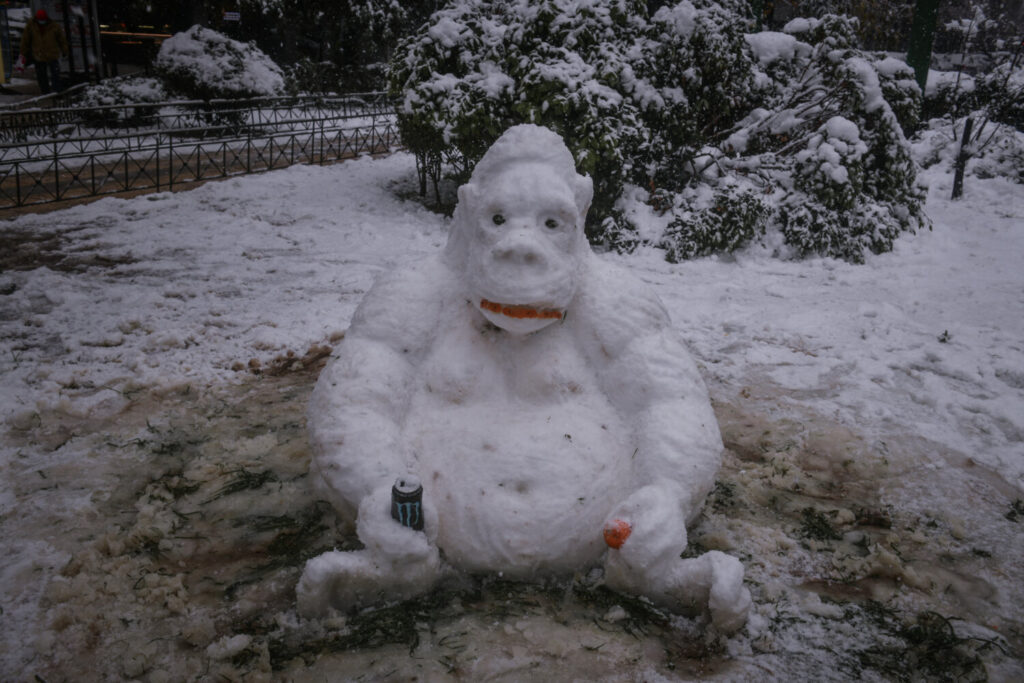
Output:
0,149,1024,677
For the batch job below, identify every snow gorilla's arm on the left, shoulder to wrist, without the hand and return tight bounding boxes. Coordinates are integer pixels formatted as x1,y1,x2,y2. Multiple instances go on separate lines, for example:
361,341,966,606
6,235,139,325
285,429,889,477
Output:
308,259,447,514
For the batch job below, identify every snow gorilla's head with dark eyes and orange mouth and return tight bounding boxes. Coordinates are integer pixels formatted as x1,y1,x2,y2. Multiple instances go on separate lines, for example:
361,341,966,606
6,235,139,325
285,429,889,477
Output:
445,124,594,334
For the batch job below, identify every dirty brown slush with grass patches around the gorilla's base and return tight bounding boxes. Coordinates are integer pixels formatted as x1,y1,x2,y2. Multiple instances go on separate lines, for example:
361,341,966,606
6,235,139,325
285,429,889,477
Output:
0,346,1024,681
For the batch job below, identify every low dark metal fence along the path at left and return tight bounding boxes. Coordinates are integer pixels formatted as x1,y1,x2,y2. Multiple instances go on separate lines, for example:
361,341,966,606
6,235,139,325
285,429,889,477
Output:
0,93,399,209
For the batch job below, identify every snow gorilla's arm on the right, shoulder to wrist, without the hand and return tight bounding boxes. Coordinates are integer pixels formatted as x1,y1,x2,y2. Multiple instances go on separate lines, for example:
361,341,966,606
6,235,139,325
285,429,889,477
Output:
570,258,722,520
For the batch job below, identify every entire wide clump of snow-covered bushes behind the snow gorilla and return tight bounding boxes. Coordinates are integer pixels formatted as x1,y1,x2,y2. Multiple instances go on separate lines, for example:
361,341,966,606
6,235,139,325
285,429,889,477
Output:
390,0,926,261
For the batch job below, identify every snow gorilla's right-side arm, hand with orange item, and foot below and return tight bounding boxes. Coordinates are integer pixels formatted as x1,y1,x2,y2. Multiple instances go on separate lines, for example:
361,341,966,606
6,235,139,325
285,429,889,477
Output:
581,259,751,632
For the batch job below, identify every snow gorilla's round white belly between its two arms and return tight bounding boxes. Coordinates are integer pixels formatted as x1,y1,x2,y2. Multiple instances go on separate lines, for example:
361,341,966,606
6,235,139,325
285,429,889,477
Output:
406,392,633,577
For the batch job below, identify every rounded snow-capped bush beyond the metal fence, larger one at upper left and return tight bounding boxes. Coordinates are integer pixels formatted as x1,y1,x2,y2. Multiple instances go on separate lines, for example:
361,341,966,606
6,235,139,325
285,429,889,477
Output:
155,26,285,99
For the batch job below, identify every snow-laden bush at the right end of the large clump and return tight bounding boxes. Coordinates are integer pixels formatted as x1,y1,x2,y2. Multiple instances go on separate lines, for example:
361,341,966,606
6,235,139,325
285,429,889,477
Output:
757,16,928,262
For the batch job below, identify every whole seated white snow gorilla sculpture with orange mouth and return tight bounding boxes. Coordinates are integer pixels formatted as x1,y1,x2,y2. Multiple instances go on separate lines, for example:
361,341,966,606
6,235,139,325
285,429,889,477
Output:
297,125,750,630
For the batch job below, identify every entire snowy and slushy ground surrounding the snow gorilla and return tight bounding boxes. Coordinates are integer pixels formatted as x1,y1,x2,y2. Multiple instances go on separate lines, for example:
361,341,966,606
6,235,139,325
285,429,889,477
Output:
0,155,1024,681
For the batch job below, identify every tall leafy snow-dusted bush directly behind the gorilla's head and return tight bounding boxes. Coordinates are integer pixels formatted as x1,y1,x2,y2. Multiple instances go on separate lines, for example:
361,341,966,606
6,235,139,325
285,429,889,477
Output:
390,0,646,229
